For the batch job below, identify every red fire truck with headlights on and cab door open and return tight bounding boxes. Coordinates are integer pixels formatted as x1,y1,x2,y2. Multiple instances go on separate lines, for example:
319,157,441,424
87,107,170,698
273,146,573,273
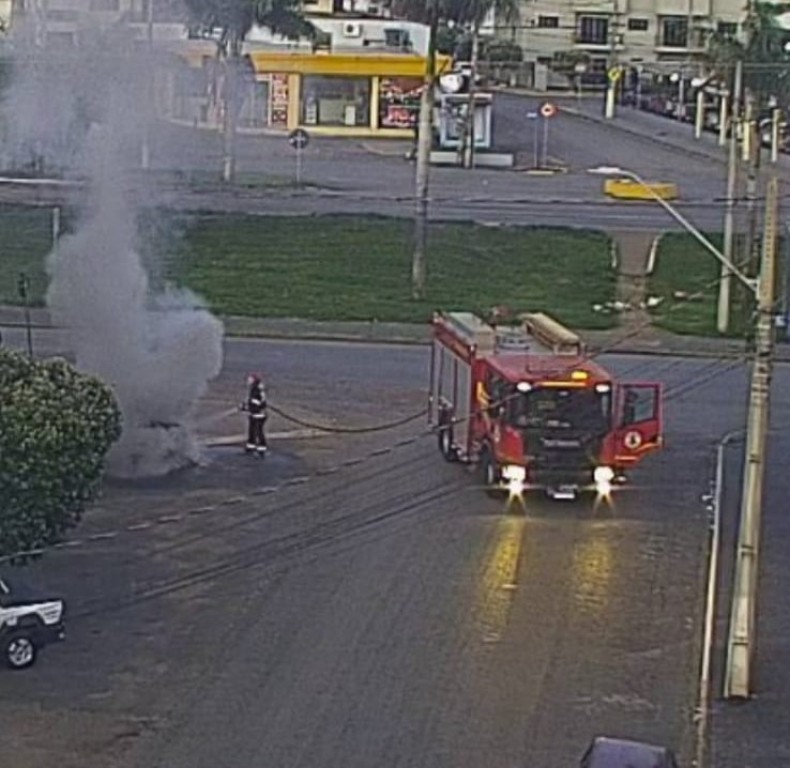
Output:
429,312,662,499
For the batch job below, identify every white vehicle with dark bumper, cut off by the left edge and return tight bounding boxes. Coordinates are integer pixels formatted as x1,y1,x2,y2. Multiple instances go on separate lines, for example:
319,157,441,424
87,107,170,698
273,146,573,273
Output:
0,577,66,669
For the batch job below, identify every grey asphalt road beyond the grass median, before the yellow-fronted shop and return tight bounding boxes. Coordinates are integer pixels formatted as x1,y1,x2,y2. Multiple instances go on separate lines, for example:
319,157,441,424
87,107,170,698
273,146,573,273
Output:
0,94,736,231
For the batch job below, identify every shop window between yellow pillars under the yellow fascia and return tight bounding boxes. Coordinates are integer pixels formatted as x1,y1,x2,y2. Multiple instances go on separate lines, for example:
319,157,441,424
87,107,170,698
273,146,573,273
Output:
301,75,371,127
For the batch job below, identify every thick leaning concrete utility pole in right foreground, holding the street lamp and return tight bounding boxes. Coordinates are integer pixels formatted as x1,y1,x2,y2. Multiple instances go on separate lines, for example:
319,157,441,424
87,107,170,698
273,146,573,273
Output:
724,177,779,698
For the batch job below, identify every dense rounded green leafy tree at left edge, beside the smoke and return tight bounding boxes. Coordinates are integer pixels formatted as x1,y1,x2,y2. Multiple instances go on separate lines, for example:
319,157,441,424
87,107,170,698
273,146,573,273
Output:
0,348,121,557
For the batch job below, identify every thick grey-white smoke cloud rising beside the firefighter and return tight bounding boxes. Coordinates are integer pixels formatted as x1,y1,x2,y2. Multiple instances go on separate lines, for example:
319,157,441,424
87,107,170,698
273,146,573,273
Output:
7,27,223,478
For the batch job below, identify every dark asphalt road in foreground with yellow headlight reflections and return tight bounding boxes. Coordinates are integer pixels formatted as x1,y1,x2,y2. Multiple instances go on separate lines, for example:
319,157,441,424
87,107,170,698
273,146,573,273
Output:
0,334,790,768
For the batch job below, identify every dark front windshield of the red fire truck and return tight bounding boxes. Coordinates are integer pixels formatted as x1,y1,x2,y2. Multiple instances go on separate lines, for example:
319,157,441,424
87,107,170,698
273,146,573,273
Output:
508,387,612,433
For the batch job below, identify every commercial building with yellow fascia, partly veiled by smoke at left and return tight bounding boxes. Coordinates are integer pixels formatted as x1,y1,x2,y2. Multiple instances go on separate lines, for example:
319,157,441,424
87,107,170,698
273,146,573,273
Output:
0,0,450,137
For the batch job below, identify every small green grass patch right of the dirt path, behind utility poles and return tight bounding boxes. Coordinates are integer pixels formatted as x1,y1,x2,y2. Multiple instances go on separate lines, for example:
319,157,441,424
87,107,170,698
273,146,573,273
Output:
648,233,746,336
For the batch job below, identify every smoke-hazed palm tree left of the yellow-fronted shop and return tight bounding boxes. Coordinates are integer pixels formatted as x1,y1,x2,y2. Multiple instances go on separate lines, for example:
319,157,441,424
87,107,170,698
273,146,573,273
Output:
184,0,316,182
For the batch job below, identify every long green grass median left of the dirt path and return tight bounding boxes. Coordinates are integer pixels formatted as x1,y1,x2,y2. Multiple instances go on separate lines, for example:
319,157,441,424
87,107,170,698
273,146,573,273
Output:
0,207,616,329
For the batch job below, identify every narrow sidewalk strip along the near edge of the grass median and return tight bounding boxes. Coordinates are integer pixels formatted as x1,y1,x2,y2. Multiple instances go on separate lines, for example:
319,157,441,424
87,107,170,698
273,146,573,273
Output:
0,306,790,362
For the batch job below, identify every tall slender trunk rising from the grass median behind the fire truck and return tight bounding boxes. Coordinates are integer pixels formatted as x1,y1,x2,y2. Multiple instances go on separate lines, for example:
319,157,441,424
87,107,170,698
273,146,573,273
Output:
411,0,439,299
